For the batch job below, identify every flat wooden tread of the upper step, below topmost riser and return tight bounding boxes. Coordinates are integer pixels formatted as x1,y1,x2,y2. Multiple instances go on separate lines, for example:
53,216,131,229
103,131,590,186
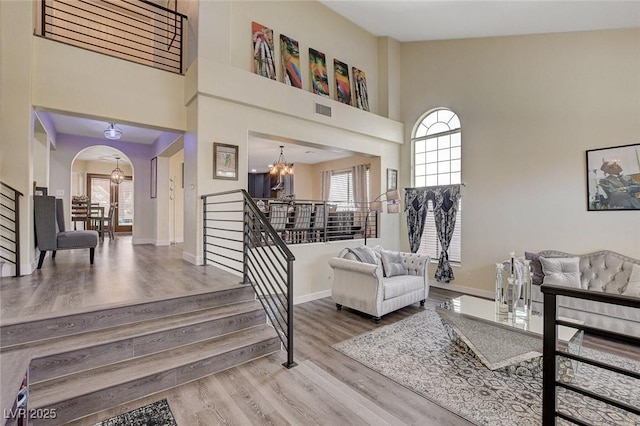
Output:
0,300,262,358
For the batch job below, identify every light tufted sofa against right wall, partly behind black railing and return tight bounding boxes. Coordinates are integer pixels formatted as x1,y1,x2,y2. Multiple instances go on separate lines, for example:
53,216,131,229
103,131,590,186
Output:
525,250,640,337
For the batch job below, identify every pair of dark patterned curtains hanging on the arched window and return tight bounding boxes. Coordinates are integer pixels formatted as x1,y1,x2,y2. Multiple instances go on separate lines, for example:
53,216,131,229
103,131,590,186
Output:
404,185,460,283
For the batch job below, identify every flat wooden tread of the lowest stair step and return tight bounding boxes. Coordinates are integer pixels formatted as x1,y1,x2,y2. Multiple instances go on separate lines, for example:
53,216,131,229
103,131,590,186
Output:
30,324,278,409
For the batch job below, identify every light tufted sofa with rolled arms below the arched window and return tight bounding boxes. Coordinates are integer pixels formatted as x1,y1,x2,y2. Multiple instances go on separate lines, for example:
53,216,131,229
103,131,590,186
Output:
329,246,430,323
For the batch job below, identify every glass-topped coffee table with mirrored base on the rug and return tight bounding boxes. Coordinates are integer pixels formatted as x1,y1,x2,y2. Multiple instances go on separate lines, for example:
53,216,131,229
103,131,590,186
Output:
436,295,583,380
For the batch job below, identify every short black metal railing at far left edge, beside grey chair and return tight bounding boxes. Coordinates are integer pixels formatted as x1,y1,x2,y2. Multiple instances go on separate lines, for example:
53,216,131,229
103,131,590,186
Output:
0,182,22,277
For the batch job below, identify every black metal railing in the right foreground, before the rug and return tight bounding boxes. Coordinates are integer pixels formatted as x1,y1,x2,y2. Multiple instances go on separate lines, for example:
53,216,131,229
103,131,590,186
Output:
541,285,640,426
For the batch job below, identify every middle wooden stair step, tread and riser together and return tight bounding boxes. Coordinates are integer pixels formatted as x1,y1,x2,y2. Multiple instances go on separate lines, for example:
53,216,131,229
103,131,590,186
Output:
26,300,266,384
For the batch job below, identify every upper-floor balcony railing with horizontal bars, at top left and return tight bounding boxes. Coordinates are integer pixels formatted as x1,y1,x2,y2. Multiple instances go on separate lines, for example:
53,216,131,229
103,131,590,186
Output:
36,0,187,74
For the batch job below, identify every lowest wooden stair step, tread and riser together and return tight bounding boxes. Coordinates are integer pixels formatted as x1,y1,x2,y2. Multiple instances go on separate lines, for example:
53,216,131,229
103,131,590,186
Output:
29,324,281,425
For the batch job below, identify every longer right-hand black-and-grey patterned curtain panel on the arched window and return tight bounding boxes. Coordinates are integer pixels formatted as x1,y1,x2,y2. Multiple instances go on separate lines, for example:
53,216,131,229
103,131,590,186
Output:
433,185,460,283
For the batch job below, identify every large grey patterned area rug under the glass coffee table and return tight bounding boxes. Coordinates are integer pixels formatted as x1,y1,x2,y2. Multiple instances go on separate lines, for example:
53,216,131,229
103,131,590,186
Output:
333,309,640,426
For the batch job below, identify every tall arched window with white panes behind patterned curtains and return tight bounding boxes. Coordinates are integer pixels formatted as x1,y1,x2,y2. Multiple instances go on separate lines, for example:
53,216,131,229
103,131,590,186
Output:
411,109,462,263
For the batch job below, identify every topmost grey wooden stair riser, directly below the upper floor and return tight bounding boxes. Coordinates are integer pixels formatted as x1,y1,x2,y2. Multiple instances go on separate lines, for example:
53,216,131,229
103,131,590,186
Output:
0,285,255,349
